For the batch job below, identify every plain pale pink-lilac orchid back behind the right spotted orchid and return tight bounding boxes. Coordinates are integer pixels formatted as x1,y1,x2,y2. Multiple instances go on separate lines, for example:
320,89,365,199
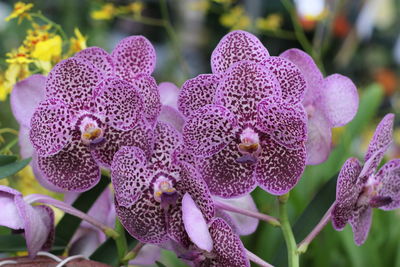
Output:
280,49,358,165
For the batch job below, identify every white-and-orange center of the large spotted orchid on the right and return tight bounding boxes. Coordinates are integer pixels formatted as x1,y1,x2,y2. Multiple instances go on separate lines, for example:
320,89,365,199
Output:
236,128,261,164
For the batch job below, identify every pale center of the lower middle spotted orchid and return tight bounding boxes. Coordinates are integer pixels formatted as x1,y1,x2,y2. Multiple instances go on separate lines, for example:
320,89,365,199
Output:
153,173,178,208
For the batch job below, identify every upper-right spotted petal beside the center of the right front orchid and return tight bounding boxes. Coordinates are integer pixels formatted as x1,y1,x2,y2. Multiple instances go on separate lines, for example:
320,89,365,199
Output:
257,97,307,151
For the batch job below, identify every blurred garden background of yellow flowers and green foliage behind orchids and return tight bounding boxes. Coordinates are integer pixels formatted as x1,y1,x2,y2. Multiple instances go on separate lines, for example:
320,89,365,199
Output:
0,0,400,267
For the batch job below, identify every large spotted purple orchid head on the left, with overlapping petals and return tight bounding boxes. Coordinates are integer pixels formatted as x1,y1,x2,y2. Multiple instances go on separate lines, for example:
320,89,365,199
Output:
26,36,161,192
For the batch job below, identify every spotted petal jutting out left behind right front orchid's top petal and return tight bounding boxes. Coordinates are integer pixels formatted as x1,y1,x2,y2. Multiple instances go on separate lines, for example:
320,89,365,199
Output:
178,74,221,117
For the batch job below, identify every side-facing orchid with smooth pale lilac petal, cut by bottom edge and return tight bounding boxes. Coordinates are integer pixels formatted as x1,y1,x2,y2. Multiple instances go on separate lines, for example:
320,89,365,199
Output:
178,193,250,267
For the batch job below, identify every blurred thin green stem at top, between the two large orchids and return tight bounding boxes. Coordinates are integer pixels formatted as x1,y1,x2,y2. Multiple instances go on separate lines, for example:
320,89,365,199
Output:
160,0,189,80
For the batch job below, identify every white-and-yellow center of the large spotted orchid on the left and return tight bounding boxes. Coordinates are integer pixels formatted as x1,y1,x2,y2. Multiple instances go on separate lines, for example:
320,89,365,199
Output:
77,114,104,145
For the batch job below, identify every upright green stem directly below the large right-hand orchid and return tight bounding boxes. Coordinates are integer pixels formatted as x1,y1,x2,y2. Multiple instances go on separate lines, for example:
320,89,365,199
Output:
278,193,299,267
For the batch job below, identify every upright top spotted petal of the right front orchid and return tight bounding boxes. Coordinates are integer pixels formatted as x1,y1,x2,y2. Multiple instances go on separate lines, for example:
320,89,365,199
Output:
215,61,282,125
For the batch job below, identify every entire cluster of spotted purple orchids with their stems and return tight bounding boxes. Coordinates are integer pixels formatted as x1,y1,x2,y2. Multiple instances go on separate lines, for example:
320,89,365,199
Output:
0,31,400,267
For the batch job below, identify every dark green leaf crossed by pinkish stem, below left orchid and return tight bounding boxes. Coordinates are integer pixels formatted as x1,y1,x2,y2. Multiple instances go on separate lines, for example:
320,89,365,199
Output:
52,176,110,254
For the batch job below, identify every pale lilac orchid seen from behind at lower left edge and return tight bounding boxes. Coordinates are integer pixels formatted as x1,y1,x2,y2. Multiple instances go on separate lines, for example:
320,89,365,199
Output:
0,185,55,258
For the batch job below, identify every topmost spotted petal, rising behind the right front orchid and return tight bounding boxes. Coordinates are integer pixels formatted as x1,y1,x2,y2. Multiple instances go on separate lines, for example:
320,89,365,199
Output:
211,31,269,74
